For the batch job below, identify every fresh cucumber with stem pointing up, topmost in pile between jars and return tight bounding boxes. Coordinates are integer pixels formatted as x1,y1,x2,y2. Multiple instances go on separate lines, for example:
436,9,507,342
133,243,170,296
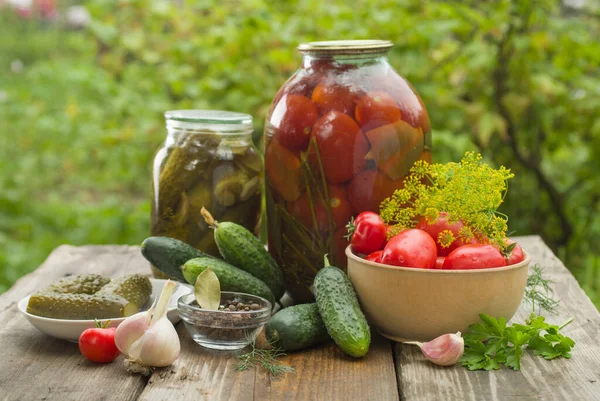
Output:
201,208,285,299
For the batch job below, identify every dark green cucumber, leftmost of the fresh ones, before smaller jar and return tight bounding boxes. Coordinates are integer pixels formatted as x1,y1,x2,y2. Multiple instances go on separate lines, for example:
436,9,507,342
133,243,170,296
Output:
142,237,209,283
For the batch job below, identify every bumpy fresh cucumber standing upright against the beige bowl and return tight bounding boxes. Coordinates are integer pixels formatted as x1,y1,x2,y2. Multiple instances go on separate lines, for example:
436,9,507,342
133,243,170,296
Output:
313,257,371,358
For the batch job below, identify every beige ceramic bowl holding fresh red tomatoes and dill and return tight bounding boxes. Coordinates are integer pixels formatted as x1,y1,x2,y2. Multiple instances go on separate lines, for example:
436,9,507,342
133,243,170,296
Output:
346,246,530,341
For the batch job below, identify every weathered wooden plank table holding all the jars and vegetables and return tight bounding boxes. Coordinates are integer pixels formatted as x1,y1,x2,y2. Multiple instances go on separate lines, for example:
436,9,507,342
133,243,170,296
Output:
0,237,600,401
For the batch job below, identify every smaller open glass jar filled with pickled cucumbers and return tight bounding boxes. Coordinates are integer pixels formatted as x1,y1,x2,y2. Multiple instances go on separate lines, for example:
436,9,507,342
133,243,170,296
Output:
151,110,263,277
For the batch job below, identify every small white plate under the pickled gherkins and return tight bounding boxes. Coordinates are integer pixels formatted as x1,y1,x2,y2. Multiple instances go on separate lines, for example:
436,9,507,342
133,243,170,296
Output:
18,278,194,342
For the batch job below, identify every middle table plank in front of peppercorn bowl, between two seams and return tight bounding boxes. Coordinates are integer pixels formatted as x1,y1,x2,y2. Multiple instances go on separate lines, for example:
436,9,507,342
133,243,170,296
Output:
140,325,399,401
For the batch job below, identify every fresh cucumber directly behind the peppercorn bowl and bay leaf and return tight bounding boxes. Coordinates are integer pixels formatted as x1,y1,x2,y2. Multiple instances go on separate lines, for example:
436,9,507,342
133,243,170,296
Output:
182,257,275,305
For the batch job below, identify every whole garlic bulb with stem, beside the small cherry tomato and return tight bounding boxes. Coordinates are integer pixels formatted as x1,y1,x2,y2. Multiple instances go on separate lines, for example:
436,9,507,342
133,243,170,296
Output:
115,280,180,374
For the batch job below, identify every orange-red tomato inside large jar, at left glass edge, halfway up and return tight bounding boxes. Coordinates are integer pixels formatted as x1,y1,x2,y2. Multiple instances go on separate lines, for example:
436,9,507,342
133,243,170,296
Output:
265,139,304,201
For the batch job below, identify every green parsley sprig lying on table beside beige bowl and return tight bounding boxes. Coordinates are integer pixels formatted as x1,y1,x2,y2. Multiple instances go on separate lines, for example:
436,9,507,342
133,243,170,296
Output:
460,313,575,370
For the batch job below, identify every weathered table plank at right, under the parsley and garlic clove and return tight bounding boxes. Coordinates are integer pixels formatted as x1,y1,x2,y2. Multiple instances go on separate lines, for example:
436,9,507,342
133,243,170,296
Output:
395,236,600,401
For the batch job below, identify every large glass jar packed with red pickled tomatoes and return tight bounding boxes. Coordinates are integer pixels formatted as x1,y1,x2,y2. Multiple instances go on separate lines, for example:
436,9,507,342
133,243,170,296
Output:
265,40,431,302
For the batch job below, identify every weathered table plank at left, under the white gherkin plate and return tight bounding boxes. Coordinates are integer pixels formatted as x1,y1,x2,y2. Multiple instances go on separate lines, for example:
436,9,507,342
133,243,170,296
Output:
0,246,150,401
